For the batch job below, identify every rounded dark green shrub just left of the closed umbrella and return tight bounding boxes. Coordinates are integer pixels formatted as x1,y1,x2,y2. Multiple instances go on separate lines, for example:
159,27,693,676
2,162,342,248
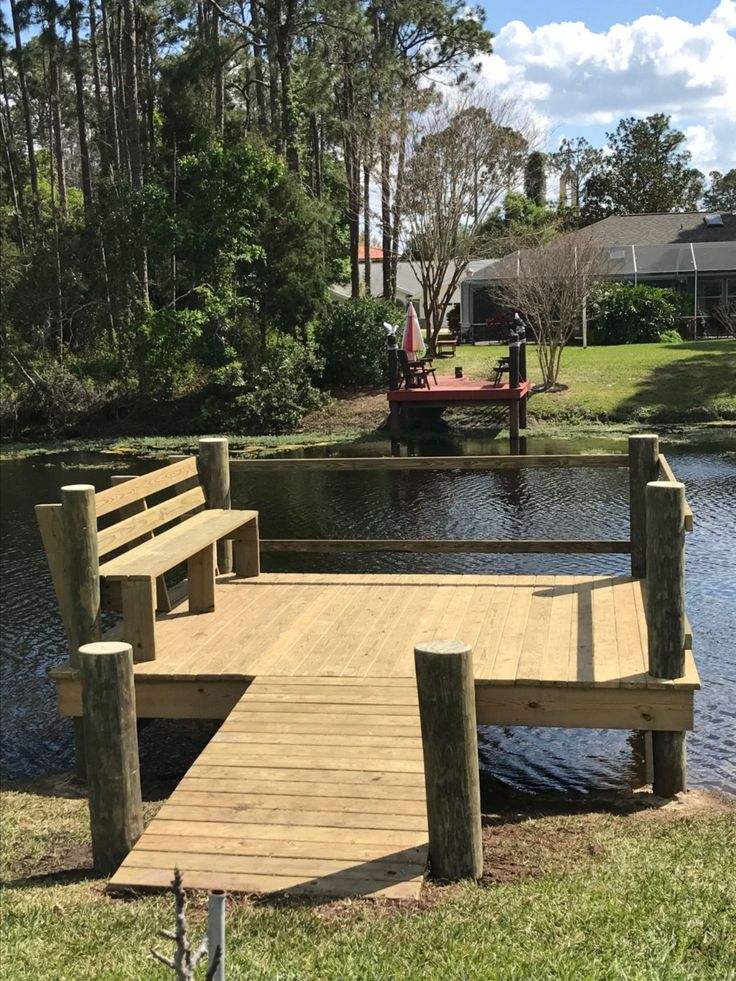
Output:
314,296,404,388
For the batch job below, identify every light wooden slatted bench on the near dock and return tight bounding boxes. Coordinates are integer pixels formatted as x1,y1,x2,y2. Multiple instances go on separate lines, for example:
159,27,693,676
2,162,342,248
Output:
36,457,259,662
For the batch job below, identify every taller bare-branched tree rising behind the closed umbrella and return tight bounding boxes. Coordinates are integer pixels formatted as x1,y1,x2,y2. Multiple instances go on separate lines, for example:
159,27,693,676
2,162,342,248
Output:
403,94,529,353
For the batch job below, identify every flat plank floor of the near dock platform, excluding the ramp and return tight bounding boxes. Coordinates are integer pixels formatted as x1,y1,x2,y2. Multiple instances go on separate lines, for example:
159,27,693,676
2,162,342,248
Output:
83,573,698,688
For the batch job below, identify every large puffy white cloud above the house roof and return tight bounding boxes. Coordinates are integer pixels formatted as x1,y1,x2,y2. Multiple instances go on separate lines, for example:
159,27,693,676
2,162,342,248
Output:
482,0,736,169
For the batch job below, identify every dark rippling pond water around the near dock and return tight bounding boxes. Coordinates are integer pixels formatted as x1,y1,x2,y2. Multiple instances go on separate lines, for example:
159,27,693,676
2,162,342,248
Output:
0,436,736,792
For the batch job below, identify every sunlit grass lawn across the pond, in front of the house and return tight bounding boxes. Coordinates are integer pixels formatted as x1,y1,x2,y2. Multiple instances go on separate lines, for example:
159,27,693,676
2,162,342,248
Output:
460,340,736,422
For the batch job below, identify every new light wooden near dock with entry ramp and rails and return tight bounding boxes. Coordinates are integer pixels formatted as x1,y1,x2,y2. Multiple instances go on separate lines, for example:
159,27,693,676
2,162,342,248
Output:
47,437,699,899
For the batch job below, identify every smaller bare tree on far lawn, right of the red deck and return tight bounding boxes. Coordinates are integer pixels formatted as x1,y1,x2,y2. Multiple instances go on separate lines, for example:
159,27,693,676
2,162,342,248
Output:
490,232,606,391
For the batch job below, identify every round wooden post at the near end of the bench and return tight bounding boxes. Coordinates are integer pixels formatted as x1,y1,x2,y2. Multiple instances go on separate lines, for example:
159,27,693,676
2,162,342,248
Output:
61,484,100,780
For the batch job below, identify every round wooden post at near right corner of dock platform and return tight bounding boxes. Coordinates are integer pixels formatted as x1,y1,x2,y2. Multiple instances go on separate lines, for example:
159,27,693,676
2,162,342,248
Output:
646,480,687,797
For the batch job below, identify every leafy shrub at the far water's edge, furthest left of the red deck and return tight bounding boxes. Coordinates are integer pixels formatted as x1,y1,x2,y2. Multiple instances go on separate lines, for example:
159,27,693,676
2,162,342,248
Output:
202,334,323,435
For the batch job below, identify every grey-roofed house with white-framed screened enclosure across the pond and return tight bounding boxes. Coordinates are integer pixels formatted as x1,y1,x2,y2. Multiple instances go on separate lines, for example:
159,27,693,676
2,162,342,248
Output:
460,212,736,341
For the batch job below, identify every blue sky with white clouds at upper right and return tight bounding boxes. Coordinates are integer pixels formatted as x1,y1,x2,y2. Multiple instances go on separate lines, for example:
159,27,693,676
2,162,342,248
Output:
474,0,736,174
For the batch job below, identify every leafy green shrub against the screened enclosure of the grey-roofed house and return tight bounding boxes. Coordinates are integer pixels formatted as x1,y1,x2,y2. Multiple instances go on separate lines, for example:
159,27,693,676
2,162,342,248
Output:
588,283,683,344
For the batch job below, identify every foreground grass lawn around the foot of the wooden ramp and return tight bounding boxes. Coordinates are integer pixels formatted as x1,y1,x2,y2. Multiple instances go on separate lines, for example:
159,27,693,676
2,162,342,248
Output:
2,778,736,981
